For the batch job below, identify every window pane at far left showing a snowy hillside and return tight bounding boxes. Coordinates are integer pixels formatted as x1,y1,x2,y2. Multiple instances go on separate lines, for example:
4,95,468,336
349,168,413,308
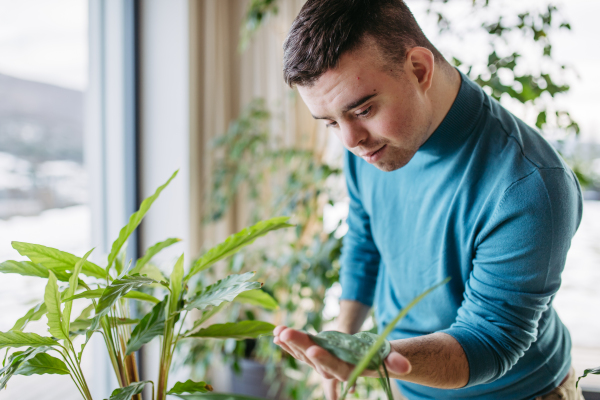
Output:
0,0,91,400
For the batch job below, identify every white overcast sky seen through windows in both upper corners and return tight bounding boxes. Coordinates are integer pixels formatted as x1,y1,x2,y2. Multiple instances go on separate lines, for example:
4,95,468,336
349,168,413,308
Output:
0,0,600,142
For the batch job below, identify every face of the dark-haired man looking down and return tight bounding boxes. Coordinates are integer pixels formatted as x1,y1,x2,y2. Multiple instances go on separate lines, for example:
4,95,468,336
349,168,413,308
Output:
298,44,432,171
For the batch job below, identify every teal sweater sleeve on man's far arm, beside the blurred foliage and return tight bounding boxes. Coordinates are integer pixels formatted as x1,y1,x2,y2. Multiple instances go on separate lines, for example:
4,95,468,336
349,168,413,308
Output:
340,150,380,307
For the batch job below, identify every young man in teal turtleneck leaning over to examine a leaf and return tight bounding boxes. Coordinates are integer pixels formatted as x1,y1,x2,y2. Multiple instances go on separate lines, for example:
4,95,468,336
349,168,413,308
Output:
275,0,582,400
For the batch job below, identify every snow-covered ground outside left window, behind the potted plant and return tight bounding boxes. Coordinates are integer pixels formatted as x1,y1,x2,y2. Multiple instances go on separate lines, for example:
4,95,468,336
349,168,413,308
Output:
0,206,96,400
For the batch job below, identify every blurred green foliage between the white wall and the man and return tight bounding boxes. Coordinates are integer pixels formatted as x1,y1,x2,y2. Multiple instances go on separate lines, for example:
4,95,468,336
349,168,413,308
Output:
186,100,344,399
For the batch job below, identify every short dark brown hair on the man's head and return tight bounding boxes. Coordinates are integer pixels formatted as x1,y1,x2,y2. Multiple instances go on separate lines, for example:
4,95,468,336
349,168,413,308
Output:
283,0,443,86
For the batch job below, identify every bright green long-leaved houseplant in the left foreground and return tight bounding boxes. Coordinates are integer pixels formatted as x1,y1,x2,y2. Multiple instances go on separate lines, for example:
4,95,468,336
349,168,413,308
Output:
0,172,291,400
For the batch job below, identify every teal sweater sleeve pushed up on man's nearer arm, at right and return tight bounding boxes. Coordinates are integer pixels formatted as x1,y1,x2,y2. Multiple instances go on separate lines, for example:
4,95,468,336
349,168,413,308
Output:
443,168,582,387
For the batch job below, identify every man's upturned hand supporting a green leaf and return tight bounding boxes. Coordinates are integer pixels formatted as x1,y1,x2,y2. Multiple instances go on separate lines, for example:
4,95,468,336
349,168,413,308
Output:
273,326,411,400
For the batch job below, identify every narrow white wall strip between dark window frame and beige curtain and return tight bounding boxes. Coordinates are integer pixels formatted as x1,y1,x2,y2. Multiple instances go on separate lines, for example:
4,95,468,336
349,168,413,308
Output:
139,0,191,267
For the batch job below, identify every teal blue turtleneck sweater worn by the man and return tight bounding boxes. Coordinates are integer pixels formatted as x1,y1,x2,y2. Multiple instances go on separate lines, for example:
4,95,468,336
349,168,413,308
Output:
341,70,582,400
